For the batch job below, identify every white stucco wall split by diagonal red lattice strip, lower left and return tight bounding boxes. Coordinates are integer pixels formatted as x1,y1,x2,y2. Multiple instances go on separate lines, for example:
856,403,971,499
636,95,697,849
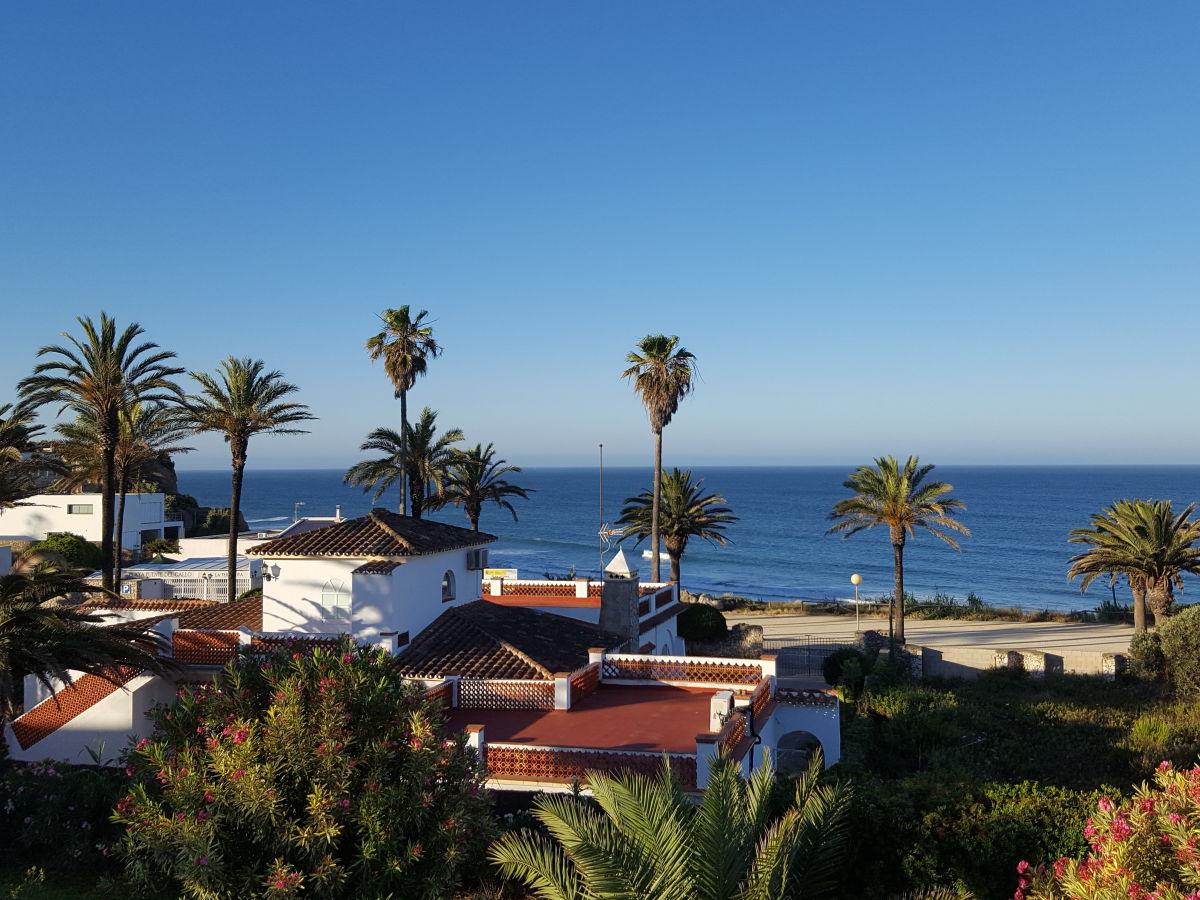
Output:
5,673,175,763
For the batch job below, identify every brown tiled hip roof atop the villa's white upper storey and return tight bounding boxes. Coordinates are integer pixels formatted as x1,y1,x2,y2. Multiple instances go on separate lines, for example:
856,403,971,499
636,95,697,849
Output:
247,509,496,559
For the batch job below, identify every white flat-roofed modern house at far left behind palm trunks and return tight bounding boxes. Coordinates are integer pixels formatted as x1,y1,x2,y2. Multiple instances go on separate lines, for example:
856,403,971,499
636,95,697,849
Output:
0,493,182,550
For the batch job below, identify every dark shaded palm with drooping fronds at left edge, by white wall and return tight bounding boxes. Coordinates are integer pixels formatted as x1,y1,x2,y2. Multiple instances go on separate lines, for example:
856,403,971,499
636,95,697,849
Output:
0,563,169,721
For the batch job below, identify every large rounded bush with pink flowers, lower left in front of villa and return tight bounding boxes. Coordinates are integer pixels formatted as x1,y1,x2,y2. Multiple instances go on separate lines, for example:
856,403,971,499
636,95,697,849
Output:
114,643,491,900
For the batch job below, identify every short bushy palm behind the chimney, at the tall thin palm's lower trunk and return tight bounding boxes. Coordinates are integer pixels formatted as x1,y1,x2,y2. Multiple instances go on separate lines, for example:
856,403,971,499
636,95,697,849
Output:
617,469,738,584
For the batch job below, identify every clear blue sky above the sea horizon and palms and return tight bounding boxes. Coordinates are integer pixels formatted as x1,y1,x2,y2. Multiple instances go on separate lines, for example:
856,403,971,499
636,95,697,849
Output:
0,0,1200,468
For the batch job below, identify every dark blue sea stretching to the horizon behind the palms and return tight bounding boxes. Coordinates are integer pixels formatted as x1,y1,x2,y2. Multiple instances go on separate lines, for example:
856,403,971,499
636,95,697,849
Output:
171,466,1200,610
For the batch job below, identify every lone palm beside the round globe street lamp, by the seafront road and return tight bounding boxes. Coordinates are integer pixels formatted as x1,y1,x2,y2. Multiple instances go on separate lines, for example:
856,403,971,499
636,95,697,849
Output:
826,456,971,643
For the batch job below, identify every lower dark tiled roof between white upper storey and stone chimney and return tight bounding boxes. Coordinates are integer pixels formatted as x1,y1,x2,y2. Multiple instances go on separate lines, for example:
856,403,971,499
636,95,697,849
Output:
396,600,620,679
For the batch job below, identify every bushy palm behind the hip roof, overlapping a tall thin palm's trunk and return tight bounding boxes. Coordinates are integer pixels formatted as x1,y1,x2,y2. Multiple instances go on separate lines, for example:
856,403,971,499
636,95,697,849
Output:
344,407,462,518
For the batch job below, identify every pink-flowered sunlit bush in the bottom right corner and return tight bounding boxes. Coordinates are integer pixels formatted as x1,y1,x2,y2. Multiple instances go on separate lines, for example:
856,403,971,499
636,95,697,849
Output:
1014,762,1200,900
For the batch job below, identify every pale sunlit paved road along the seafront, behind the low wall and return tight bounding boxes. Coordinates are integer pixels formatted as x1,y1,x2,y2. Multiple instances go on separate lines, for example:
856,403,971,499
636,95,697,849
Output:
725,613,1133,653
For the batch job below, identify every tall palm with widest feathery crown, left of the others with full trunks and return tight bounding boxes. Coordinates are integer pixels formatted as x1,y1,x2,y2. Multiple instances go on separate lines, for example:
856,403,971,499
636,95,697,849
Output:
19,312,184,590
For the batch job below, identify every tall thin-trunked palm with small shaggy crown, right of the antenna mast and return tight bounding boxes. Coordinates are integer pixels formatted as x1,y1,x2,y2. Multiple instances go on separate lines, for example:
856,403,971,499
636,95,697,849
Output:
620,335,696,581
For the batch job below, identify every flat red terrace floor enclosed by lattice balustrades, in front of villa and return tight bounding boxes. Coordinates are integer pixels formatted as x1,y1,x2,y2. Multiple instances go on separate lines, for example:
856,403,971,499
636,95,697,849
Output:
448,685,715,754
